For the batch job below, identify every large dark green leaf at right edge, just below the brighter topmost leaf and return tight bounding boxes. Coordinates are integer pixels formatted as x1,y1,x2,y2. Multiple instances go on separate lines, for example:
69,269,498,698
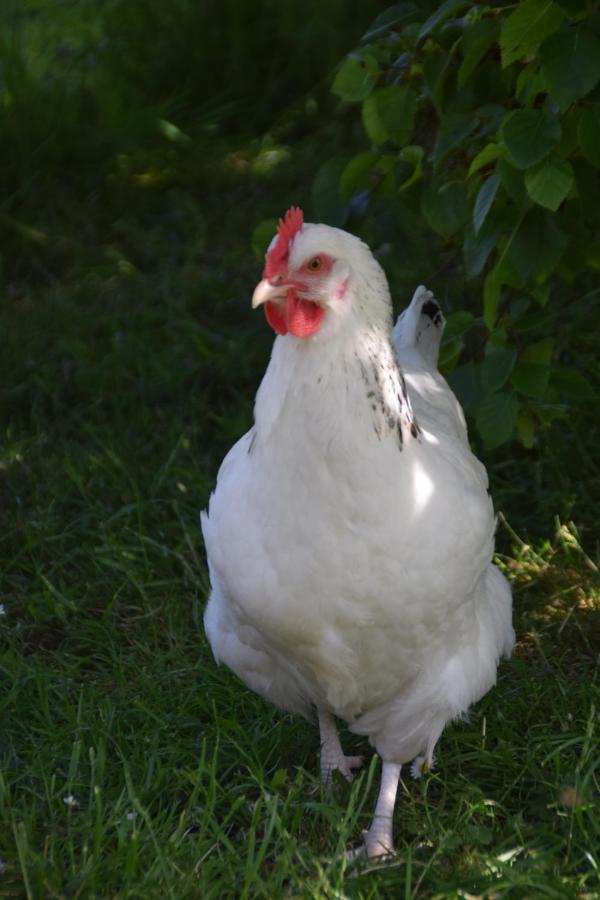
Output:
540,28,600,109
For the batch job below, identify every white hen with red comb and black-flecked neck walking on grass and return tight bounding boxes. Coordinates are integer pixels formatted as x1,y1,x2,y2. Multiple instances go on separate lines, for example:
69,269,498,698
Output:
202,208,514,856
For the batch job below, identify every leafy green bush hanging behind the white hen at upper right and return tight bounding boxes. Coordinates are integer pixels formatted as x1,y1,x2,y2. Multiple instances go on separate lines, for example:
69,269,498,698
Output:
313,0,600,448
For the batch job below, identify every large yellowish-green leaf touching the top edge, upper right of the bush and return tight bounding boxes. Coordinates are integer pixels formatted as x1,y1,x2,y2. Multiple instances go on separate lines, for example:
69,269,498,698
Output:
500,0,564,69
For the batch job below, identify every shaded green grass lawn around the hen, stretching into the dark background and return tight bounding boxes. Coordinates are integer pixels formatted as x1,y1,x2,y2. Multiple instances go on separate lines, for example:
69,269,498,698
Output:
0,2,600,900
